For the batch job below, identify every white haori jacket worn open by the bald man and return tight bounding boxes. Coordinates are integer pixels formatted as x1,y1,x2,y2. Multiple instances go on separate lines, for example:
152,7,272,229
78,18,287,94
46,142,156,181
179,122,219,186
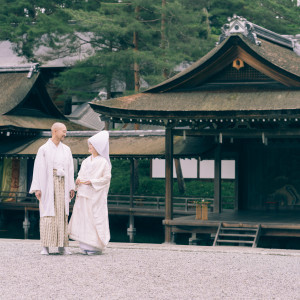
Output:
29,139,75,217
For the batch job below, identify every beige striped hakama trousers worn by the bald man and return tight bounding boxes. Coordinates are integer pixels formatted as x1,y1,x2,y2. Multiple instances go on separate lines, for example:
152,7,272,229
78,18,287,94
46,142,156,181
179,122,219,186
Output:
40,170,69,247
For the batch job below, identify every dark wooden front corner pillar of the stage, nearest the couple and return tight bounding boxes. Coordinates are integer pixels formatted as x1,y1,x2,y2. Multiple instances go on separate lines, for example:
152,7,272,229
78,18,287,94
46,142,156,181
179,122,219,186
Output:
165,127,173,243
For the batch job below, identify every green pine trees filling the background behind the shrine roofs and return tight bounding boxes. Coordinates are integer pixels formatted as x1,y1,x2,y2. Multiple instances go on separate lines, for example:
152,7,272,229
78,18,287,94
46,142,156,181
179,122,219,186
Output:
0,0,300,104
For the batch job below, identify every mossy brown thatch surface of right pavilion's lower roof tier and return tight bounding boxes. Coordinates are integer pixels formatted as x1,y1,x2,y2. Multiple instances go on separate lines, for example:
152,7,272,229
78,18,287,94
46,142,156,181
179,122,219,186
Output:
93,90,300,116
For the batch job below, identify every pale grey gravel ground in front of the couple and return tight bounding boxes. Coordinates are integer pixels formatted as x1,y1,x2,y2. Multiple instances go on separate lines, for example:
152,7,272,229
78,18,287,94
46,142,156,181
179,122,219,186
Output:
0,239,300,300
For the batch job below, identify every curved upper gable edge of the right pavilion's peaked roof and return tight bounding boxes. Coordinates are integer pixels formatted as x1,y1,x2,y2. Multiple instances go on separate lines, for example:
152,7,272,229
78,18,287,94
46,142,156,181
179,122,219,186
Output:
145,35,300,93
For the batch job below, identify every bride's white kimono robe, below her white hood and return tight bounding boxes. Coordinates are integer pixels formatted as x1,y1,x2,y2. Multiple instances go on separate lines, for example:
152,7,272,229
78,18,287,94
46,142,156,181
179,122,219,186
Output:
69,156,111,250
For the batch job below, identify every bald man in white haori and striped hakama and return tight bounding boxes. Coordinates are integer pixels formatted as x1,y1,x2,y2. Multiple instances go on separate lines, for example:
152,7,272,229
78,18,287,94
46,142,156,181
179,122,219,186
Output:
29,123,75,255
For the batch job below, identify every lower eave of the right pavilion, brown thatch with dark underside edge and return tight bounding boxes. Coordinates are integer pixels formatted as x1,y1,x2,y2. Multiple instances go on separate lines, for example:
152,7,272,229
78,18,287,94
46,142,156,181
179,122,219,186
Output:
90,89,300,119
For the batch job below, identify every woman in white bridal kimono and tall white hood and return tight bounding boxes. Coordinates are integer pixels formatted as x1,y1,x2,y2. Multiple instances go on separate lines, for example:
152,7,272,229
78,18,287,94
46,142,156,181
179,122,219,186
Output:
69,131,111,255
